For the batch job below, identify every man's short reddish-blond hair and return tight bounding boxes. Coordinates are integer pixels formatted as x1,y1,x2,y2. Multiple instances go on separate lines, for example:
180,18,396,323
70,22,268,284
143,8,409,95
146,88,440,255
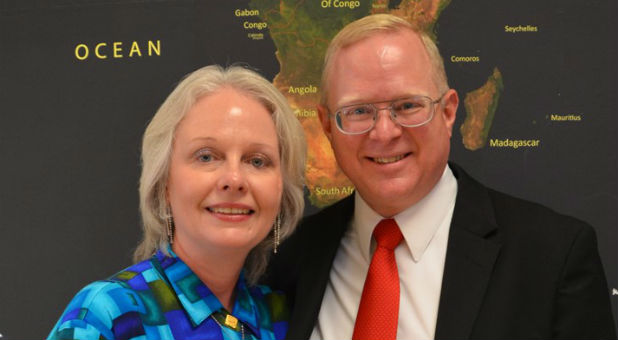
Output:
320,14,449,106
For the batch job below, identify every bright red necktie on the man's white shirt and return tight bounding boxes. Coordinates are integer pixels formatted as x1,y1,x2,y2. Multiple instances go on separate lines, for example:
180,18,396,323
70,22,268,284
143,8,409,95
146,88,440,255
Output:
352,218,403,340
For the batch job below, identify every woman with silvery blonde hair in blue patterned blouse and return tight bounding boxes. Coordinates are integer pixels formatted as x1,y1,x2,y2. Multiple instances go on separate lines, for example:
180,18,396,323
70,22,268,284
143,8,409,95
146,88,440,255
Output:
49,66,305,339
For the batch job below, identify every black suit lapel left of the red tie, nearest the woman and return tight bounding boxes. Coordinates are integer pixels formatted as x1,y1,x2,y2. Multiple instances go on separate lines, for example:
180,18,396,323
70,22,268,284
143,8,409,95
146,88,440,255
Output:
286,195,354,339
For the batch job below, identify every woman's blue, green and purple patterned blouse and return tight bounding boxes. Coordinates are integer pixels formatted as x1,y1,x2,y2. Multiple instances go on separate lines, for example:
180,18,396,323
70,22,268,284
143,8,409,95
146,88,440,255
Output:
48,250,288,340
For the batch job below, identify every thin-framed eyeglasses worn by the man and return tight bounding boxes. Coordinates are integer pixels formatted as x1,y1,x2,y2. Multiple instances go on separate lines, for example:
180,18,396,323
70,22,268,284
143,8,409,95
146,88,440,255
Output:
334,93,446,135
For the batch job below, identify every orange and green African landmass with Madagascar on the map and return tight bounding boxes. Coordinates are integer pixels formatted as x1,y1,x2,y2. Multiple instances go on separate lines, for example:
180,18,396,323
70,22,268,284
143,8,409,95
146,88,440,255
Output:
250,0,503,207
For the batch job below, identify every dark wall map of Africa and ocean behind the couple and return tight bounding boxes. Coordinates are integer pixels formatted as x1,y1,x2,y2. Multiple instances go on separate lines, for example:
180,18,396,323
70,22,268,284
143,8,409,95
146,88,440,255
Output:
0,0,618,339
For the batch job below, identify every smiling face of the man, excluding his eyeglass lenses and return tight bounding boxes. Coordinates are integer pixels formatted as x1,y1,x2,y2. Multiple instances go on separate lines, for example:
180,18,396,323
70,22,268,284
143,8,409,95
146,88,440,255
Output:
318,30,458,217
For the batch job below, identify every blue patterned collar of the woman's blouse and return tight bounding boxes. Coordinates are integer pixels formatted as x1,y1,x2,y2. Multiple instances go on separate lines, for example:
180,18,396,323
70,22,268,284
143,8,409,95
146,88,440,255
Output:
154,247,261,339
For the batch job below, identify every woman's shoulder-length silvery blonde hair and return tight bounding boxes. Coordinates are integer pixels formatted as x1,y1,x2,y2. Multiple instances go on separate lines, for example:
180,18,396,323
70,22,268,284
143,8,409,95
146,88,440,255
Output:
133,65,306,284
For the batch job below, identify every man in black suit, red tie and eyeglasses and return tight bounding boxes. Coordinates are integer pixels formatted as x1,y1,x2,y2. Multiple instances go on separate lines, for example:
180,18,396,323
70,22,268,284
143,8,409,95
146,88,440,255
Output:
270,14,616,339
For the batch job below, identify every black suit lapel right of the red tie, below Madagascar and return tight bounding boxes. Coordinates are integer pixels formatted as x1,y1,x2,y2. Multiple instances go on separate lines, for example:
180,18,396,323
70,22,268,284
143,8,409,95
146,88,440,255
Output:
435,164,500,339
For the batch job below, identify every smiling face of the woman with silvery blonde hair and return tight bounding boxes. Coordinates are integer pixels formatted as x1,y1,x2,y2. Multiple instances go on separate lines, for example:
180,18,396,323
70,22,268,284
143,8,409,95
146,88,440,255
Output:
167,87,283,253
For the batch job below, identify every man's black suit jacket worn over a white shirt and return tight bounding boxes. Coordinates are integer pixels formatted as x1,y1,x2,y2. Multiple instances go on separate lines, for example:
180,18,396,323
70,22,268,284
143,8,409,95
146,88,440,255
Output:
267,164,616,339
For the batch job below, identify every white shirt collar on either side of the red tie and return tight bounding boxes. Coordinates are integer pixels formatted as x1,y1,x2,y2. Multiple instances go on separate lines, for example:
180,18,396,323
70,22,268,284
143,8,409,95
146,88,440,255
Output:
352,165,457,262
